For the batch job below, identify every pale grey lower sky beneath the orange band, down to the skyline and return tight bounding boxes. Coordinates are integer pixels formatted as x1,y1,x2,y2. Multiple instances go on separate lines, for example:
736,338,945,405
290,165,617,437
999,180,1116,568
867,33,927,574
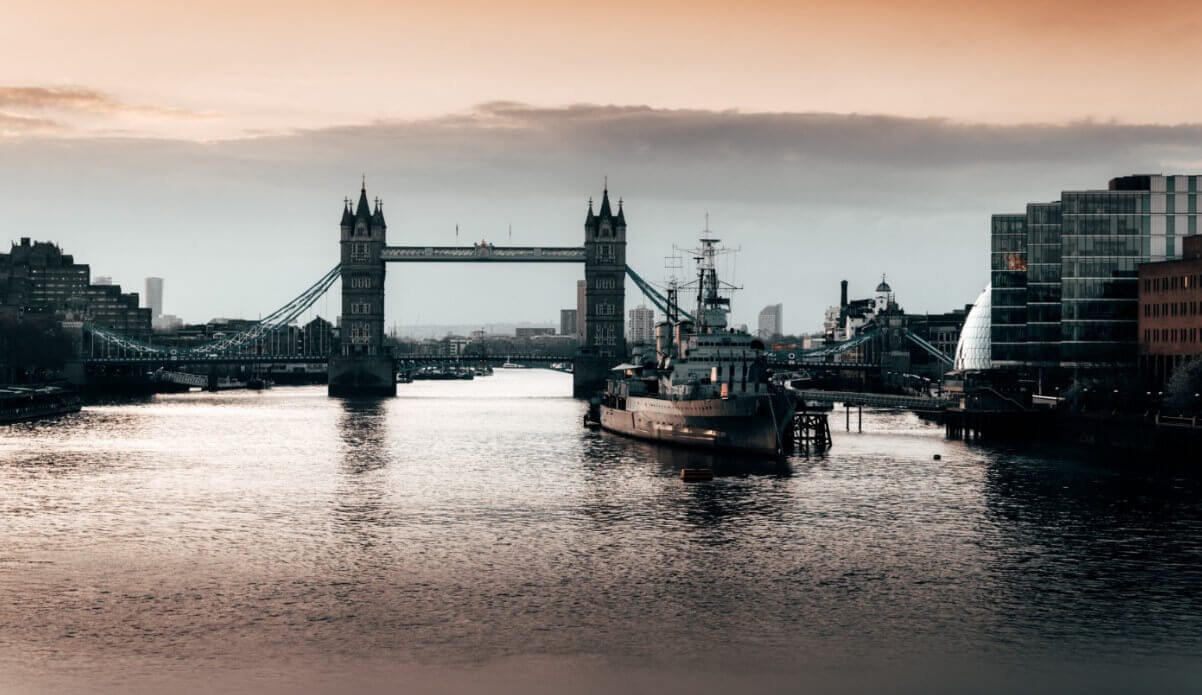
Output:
0,102,1202,329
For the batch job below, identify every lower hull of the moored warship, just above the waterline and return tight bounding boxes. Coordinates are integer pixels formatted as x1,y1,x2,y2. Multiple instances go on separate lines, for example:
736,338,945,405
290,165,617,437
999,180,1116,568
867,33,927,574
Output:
601,396,793,456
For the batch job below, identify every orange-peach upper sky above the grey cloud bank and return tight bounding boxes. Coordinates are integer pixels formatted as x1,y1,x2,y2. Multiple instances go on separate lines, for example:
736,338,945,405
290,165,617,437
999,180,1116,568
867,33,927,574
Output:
0,0,1202,139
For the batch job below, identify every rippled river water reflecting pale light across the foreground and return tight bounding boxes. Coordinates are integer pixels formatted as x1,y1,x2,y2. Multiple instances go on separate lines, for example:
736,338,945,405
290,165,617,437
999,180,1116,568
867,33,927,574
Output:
0,369,1202,693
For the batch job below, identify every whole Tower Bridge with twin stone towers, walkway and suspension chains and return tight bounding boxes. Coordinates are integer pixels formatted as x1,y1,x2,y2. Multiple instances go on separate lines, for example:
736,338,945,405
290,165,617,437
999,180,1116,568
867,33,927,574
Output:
72,177,950,397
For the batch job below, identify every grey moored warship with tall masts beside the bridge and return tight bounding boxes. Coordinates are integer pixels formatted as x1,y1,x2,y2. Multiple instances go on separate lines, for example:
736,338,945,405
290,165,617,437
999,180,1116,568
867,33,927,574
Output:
597,235,795,456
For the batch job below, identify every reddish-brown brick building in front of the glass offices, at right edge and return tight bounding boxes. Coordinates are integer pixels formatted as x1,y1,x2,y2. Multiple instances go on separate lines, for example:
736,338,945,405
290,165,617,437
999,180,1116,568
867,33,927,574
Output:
1138,236,1202,384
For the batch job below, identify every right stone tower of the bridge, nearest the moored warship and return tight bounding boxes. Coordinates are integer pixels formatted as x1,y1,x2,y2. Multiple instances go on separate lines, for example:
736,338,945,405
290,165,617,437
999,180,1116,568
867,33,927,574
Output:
572,185,626,398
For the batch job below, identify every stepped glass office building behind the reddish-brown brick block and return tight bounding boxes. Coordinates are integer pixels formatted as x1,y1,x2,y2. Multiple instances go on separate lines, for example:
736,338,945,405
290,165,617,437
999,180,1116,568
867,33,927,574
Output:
990,176,1202,369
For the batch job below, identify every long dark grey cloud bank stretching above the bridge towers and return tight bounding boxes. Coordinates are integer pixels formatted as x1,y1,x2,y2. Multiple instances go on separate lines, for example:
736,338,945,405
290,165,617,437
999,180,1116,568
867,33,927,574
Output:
234,102,1202,209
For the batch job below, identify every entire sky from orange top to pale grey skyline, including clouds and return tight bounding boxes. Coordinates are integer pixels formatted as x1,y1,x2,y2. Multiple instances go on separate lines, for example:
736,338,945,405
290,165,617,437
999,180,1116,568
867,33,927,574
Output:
0,0,1202,332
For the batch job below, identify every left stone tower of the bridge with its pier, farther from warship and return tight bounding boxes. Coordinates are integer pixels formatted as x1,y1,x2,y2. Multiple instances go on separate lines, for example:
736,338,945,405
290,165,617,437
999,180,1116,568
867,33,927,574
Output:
329,182,397,397
